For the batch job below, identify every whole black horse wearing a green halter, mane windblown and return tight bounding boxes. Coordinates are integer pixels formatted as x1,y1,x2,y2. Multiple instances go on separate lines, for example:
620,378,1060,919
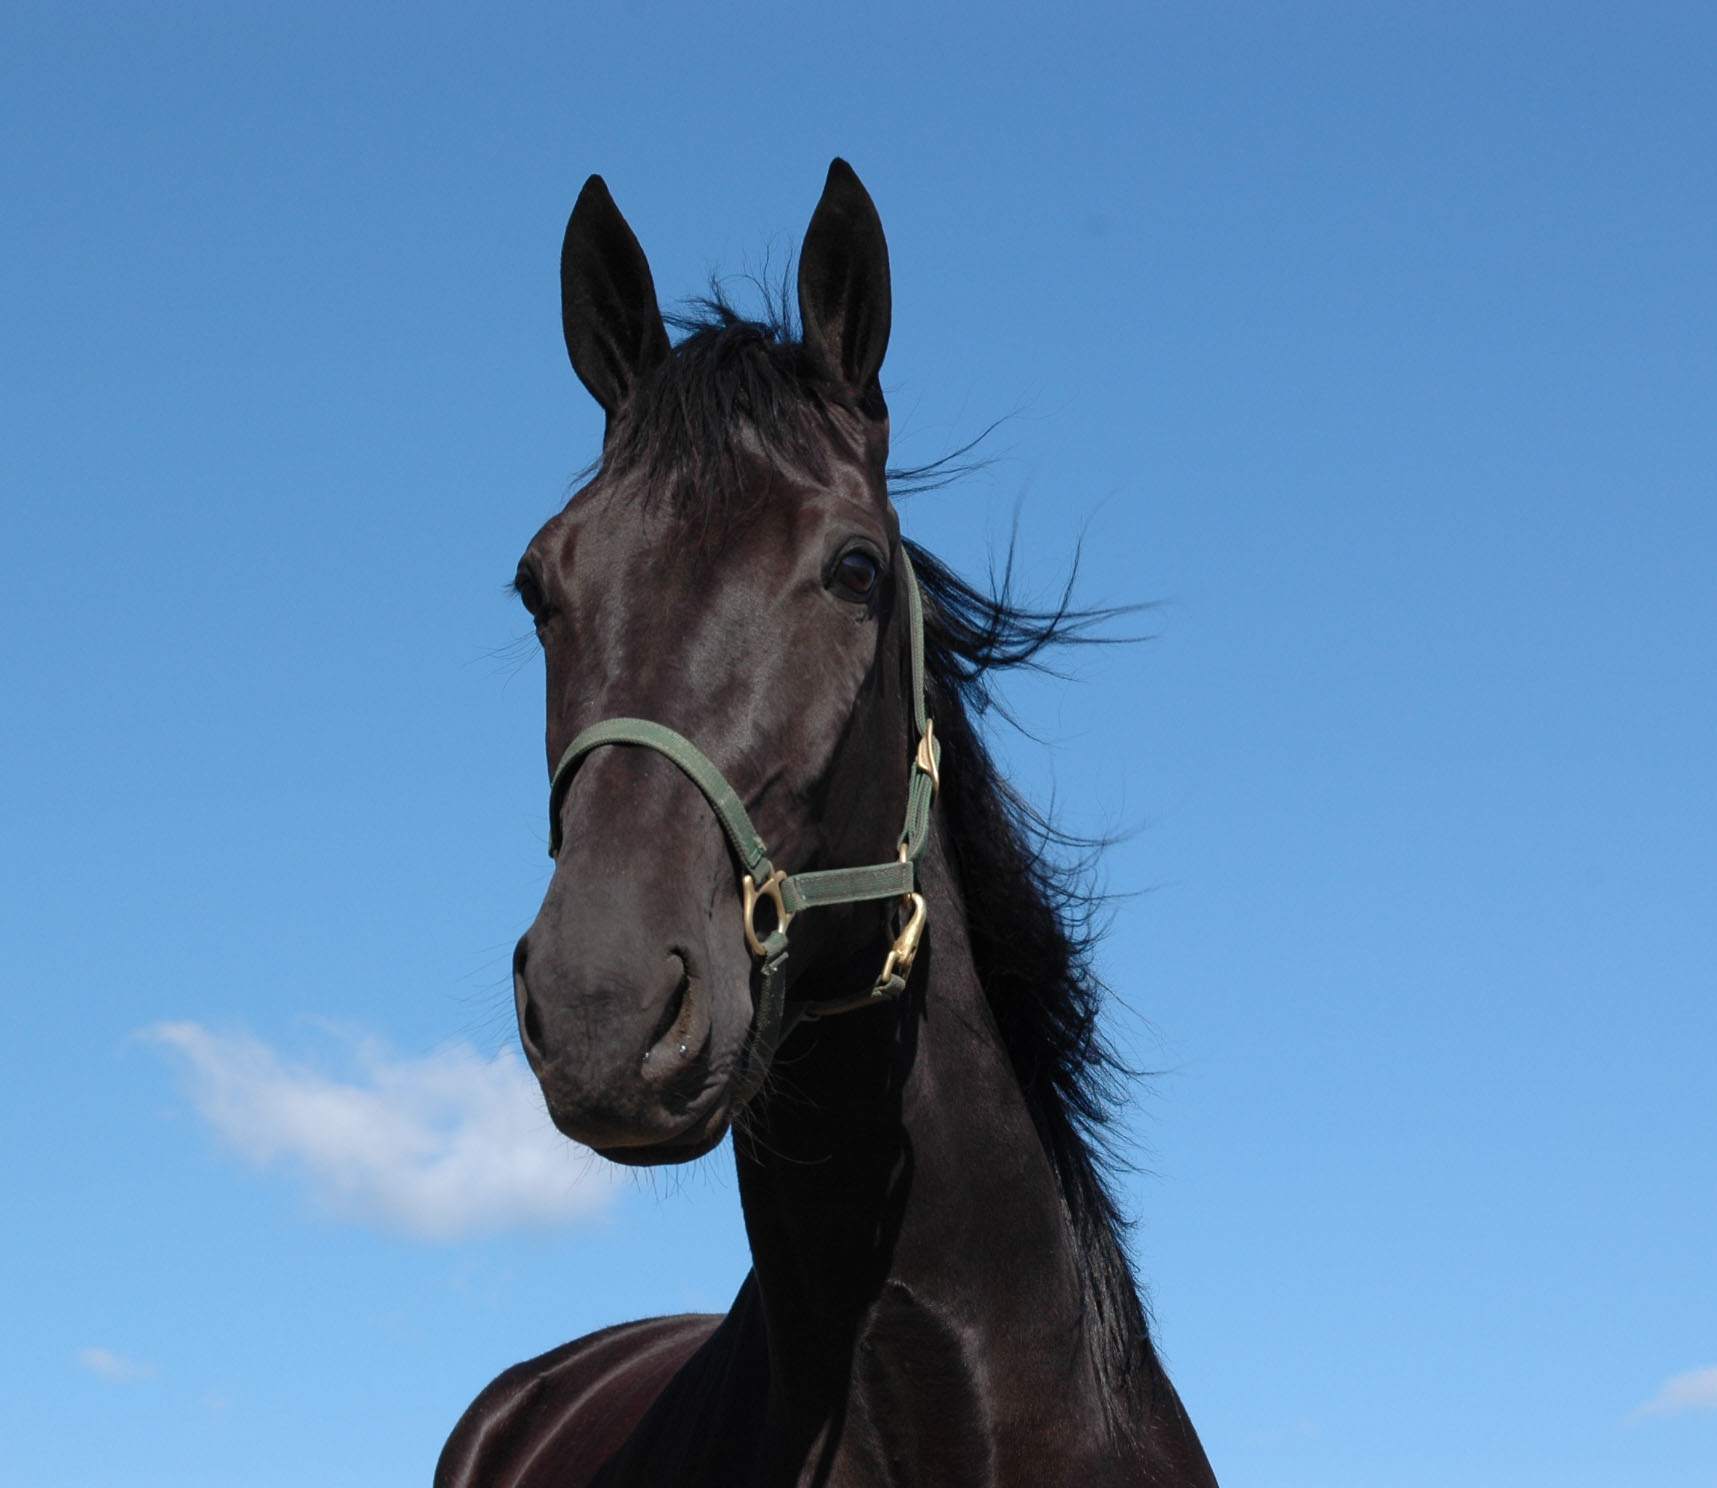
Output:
434,160,1216,1488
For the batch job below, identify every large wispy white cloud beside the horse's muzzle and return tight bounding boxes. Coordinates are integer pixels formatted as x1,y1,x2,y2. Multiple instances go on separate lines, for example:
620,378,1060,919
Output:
146,1023,615,1239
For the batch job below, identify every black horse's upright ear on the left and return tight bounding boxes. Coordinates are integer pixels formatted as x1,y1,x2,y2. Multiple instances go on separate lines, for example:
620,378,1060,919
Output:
560,175,671,424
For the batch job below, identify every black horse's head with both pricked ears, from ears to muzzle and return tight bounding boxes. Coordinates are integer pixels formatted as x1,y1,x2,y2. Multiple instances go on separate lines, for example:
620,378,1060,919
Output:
513,161,934,1164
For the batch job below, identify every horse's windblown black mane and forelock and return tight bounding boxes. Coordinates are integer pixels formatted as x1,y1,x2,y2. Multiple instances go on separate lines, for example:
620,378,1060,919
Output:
603,302,1152,1402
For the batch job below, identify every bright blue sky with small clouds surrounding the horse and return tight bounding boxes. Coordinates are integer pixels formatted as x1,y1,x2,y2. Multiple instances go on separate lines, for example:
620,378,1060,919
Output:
0,0,1717,1488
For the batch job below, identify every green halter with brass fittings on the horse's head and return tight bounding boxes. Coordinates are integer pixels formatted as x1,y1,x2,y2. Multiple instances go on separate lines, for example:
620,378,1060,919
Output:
548,547,943,1105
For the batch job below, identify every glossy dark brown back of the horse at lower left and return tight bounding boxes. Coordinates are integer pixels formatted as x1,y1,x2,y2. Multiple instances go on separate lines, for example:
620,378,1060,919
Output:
434,1313,721,1488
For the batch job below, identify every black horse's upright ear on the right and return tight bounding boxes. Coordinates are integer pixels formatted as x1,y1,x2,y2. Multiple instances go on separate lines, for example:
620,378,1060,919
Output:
798,160,891,417
